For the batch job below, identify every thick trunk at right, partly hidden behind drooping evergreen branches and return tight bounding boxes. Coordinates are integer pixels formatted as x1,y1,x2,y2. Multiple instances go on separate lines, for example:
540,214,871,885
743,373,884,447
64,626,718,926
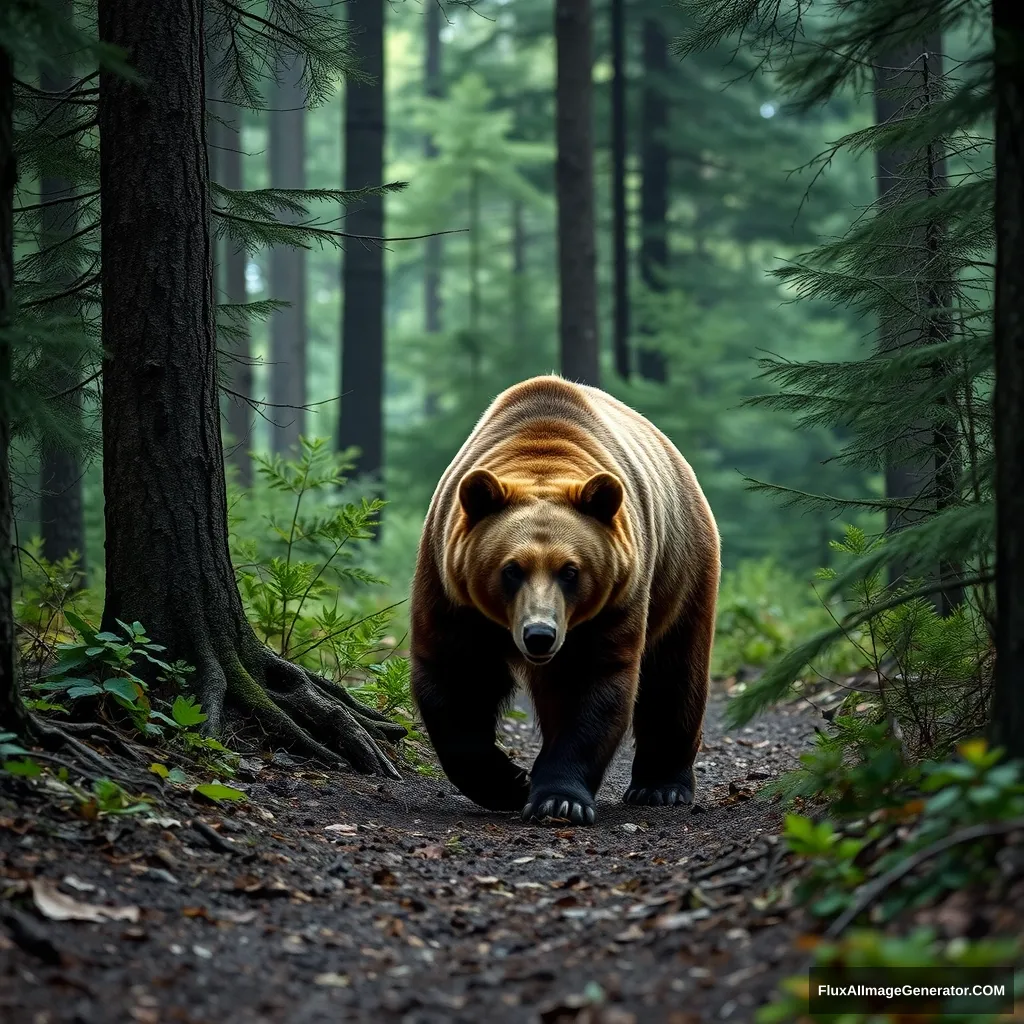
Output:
874,35,963,611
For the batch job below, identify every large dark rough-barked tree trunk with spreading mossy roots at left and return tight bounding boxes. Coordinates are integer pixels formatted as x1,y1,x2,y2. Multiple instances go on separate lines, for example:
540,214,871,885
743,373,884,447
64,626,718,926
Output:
98,0,403,774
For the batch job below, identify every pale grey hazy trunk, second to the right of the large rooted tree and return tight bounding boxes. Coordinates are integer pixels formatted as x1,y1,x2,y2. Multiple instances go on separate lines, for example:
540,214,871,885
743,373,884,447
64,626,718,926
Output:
269,59,306,455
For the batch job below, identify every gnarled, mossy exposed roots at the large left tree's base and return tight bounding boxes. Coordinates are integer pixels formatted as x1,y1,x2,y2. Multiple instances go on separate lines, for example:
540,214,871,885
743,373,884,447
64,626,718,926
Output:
190,638,407,778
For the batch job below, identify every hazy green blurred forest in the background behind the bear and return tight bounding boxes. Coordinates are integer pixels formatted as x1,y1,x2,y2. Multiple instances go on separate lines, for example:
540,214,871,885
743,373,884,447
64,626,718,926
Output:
15,0,882,663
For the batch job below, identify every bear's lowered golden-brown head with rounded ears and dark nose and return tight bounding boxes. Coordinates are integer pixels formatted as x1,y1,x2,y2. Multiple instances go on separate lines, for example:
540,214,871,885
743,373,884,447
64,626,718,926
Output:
447,469,632,665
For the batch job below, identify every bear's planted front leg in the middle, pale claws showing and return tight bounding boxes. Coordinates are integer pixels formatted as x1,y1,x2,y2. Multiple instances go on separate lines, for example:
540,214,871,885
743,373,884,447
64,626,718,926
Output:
522,630,641,824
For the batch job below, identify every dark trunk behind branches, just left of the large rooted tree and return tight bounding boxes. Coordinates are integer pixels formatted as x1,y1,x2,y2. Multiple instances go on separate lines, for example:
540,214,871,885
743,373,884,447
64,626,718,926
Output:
39,0,86,573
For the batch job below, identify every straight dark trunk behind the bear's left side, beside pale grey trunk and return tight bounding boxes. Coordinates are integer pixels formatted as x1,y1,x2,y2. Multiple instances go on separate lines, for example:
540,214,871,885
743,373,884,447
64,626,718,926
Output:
338,0,384,491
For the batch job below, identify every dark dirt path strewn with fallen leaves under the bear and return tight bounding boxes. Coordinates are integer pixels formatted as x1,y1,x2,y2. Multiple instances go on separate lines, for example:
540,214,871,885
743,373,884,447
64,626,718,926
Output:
0,679,814,1024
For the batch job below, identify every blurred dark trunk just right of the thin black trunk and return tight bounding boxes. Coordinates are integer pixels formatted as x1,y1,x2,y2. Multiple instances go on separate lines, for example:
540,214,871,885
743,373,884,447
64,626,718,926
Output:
637,17,669,384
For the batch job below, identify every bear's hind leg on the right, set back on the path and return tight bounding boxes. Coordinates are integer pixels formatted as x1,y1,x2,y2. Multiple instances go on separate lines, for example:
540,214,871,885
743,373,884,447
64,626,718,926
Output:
623,590,716,806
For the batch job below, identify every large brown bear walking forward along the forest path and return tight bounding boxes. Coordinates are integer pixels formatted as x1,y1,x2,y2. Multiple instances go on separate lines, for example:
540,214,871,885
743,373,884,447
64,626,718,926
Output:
410,375,721,824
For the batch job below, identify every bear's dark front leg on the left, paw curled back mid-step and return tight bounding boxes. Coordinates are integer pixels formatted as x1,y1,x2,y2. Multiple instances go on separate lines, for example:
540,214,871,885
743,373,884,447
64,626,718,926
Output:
412,650,529,811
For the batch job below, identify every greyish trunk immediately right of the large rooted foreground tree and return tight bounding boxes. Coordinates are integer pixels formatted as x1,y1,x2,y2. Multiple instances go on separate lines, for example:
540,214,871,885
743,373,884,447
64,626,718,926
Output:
207,57,253,487
